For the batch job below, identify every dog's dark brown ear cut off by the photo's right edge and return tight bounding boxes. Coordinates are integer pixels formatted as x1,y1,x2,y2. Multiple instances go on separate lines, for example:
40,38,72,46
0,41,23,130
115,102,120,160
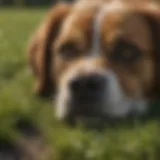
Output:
131,0,160,99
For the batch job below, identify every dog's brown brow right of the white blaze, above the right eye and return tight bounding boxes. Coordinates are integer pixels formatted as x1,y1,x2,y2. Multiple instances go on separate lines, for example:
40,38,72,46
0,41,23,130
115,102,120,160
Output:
93,1,157,52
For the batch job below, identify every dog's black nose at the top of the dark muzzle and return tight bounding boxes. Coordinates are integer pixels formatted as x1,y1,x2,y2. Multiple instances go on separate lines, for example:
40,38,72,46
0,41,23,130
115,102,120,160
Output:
70,74,106,96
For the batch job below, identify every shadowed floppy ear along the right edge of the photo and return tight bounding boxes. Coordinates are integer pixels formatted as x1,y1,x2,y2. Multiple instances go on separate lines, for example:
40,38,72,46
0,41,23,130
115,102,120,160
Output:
138,3,160,99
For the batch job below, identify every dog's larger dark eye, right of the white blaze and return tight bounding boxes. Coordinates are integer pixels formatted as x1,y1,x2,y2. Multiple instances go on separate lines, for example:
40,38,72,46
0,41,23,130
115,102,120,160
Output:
110,41,142,63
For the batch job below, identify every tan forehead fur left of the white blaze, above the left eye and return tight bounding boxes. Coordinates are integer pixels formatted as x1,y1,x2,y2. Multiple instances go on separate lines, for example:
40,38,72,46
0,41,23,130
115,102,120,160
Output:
57,0,101,45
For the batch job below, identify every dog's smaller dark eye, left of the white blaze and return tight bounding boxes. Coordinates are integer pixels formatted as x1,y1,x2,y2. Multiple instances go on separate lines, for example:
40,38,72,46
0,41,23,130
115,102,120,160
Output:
58,42,79,59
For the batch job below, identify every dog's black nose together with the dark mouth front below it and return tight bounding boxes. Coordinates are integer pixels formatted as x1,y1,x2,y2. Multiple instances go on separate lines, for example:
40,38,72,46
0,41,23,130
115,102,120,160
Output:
69,73,107,115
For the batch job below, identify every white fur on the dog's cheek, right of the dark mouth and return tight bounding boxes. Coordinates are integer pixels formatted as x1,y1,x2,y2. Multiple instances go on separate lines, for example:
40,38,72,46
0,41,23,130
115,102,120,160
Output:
104,71,147,117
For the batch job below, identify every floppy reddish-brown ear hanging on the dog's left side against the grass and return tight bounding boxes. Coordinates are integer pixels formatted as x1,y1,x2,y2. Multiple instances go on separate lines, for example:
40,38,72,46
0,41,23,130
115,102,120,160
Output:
28,3,71,97
